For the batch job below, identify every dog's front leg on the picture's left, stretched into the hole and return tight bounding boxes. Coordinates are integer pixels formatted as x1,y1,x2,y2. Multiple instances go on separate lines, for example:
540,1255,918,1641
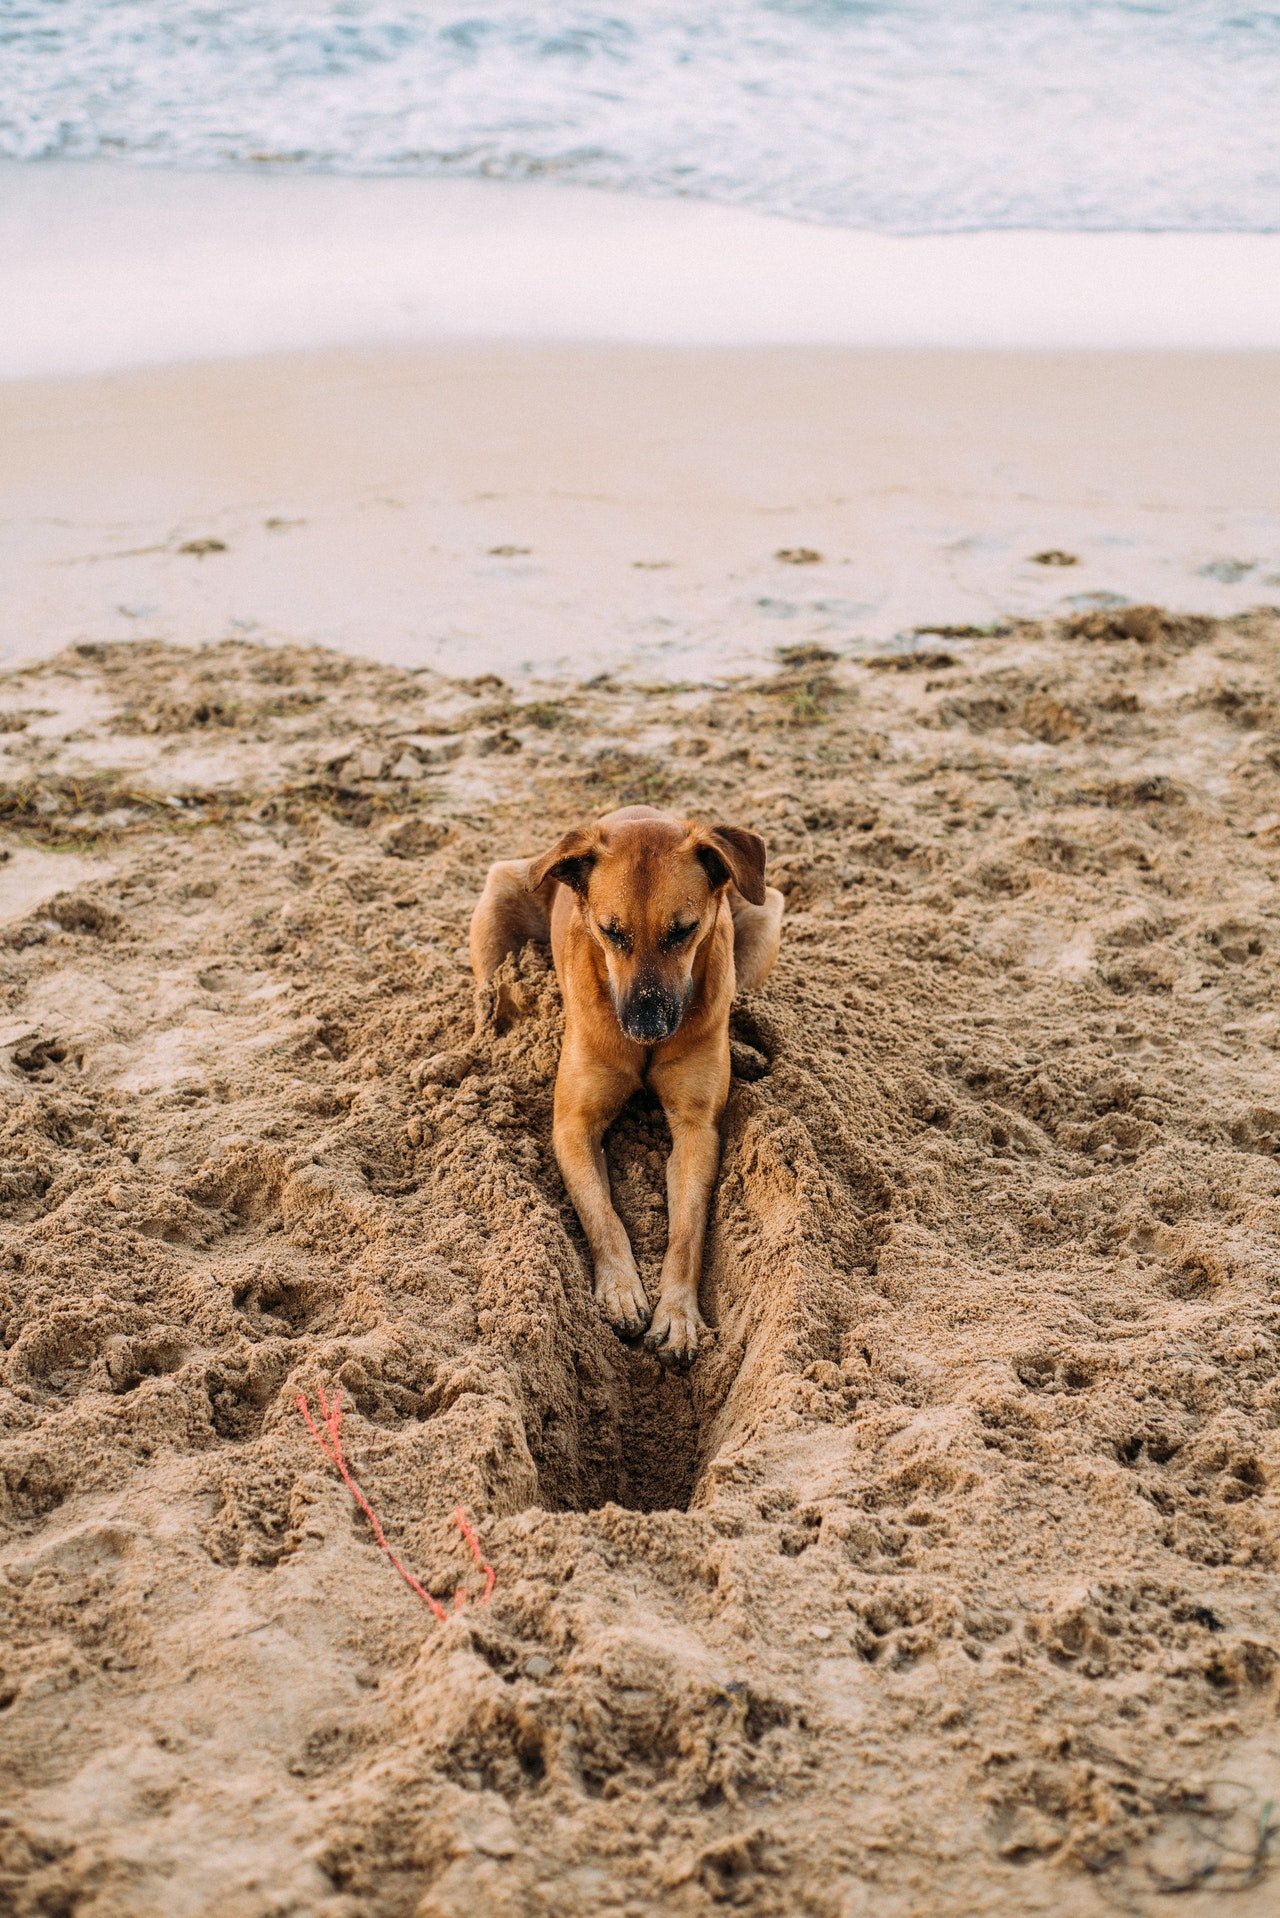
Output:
553,1043,651,1339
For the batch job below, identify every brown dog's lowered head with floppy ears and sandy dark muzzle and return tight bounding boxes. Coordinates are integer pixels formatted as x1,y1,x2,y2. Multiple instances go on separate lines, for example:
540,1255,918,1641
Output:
530,806,764,1045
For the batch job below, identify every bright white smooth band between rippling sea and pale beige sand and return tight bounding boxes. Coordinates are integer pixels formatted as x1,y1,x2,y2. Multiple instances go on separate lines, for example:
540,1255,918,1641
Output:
0,161,1280,378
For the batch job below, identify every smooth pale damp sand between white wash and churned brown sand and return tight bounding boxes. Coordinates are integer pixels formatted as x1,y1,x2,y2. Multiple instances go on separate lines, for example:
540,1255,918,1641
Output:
0,341,1280,677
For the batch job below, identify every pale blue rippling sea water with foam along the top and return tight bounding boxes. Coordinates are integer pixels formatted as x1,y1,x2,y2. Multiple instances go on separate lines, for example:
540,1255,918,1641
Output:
0,0,1280,234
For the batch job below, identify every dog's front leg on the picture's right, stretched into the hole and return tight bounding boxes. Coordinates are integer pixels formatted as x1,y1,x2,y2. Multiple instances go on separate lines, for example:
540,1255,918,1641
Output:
645,1034,729,1366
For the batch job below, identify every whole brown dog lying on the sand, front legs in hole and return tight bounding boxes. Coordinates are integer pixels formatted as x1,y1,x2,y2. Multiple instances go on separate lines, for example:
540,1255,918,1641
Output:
470,806,783,1364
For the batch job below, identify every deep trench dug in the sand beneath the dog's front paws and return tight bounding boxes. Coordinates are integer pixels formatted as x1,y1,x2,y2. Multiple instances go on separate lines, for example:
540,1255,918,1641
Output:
493,1011,855,1513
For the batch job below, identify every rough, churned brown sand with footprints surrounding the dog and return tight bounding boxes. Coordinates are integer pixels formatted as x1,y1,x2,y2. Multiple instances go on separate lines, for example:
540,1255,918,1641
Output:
0,612,1280,1918
